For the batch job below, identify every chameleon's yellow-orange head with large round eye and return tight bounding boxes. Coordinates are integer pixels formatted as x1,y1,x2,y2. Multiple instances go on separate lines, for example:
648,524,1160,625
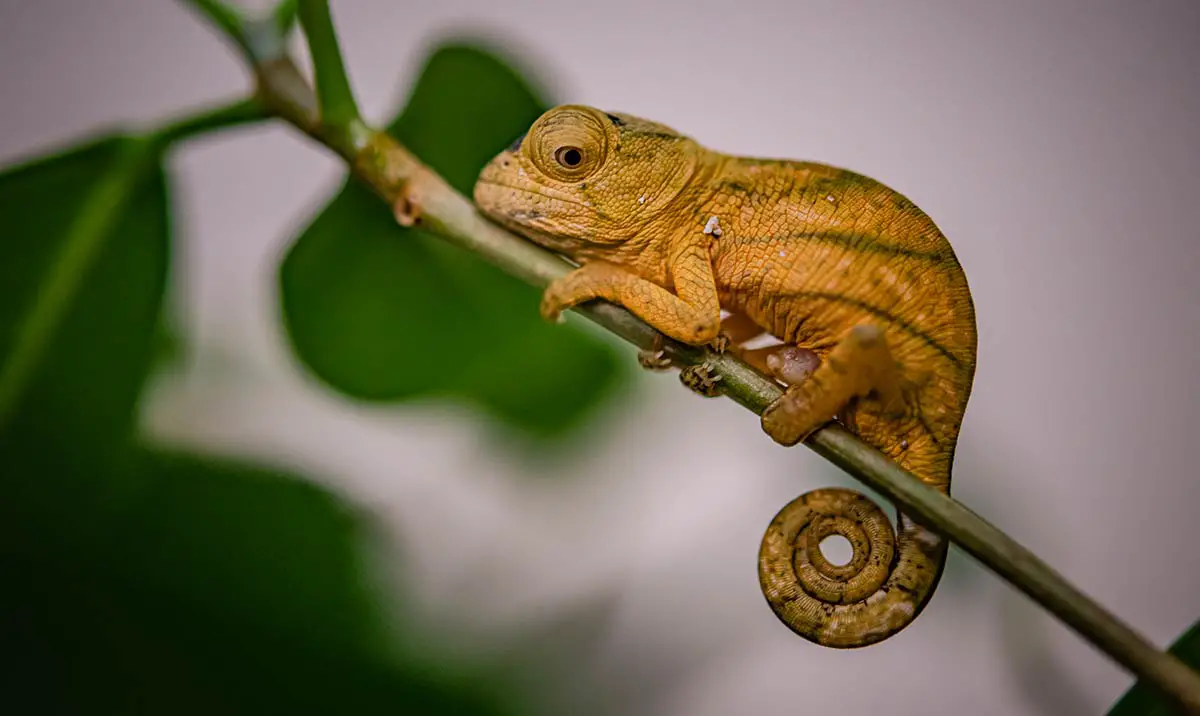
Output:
474,104,703,255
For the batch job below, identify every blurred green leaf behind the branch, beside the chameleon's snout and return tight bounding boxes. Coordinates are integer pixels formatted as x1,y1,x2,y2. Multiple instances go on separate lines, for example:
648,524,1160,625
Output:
281,44,628,437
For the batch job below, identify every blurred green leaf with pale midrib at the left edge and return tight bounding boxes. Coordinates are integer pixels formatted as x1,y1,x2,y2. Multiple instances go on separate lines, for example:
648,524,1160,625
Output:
0,137,169,443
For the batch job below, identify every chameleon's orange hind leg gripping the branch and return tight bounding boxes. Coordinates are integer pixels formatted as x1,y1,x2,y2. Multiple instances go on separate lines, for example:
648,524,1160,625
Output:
762,325,904,446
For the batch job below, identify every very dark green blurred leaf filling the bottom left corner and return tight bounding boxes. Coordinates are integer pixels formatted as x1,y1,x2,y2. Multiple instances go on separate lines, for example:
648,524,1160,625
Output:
0,452,516,715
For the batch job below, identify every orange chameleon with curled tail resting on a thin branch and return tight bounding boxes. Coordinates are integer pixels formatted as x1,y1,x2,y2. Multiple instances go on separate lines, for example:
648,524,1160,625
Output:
473,104,977,649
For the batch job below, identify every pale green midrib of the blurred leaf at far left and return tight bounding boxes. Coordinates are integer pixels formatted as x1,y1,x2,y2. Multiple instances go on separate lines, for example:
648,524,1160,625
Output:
0,137,155,431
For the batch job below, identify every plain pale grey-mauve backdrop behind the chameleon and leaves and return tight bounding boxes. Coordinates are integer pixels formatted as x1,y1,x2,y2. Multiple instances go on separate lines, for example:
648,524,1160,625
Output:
0,0,1200,716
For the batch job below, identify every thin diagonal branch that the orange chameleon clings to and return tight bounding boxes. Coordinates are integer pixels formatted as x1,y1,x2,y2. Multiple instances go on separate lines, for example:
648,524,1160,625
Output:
187,0,1200,712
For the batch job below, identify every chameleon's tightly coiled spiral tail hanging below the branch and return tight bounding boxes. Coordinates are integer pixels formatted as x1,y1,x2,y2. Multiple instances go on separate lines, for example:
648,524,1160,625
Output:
758,488,947,649
